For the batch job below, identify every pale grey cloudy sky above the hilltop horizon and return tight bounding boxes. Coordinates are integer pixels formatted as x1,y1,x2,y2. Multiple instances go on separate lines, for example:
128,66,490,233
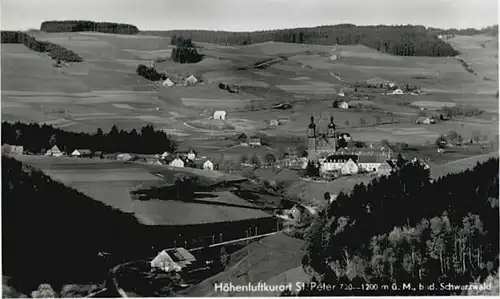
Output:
1,0,498,31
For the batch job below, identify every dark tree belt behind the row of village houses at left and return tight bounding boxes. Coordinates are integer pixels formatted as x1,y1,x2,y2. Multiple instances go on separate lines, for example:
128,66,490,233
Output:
2,122,177,154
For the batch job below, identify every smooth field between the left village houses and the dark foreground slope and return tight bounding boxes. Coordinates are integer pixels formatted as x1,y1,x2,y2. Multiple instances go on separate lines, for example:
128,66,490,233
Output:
16,156,269,225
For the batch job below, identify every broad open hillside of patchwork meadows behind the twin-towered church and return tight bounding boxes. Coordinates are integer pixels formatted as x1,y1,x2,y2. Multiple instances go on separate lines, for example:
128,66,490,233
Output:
1,32,498,163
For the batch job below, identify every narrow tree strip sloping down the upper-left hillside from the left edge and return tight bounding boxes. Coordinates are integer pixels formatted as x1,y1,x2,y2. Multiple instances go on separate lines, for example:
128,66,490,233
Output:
2,31,83,62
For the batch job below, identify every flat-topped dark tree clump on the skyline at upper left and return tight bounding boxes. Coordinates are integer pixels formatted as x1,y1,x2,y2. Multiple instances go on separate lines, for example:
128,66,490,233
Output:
40,20,139,34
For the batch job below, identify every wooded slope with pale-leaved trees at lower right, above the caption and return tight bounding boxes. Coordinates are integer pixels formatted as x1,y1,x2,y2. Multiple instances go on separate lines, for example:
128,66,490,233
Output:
301,158,499,296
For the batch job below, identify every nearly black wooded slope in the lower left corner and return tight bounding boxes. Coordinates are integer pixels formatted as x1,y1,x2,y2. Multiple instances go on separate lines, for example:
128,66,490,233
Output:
2,156,143,293
